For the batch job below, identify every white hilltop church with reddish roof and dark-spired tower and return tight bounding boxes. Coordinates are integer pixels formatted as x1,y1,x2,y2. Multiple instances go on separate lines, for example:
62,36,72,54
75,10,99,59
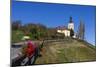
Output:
57,17,76,38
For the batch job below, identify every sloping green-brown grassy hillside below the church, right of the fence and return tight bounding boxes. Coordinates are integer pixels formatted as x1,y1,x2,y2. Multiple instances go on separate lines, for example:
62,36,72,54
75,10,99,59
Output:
35,39,96,64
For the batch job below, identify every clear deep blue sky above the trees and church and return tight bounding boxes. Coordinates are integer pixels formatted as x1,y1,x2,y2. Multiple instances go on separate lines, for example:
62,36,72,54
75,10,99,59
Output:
11,1,96,45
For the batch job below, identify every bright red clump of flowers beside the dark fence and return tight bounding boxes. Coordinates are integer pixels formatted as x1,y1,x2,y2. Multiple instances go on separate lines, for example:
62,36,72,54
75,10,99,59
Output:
26,42,36,58
